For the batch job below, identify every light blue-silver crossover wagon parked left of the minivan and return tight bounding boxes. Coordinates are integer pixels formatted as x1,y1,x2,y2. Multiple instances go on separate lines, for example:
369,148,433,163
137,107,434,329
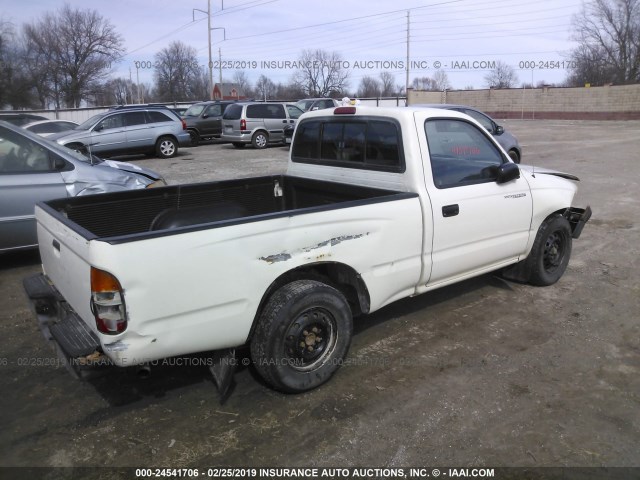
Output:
49,105,191,158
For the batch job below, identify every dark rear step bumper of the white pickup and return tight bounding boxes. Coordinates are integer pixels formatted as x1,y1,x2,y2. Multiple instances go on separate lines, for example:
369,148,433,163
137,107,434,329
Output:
23,273,110,376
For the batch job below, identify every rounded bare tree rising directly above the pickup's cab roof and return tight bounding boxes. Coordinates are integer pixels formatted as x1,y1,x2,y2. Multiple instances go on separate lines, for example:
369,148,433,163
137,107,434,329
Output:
293,50,349,97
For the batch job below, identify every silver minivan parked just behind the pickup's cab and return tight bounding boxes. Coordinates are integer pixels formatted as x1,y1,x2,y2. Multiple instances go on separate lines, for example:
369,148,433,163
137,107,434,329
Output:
222,102,304,148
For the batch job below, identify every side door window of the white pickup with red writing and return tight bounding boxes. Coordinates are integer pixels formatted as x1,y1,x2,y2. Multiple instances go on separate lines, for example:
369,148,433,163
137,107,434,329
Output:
425,119,505,188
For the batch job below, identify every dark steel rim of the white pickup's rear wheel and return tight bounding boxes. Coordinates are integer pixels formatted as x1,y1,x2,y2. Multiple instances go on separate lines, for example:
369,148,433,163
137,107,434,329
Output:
284,307,338,372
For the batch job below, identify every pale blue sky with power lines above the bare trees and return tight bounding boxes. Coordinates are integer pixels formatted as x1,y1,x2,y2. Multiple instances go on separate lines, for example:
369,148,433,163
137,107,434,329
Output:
0,0,582,92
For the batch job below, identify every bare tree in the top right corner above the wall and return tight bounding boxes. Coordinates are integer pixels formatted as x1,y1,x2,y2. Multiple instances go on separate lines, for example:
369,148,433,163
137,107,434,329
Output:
568,0,640,85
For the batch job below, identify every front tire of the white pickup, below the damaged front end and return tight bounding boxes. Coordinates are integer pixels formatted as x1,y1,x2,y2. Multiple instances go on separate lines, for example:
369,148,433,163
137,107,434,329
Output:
525,214,572,286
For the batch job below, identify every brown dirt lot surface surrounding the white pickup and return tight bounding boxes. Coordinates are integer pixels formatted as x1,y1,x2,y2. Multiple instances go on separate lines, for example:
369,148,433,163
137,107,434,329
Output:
0,120,640,468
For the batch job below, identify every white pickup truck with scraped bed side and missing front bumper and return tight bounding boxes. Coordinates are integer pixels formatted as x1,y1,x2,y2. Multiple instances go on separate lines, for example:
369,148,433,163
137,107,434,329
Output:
24,106,591,392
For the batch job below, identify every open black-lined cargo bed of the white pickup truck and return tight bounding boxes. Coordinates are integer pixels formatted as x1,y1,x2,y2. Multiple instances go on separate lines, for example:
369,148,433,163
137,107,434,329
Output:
41,175,415,244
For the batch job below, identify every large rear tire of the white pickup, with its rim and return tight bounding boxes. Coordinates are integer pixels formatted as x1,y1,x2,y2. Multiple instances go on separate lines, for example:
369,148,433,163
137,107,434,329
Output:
251,280,353,393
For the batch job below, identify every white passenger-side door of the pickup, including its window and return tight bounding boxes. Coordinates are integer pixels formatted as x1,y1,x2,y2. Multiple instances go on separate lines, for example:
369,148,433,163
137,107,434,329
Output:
416,112,532,286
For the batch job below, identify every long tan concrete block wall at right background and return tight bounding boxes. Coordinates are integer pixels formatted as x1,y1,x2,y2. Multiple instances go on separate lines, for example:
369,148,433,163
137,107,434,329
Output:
407,84,640,120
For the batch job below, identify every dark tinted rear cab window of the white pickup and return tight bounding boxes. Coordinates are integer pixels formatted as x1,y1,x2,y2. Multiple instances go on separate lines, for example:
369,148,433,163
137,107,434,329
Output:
291,117,405,172
